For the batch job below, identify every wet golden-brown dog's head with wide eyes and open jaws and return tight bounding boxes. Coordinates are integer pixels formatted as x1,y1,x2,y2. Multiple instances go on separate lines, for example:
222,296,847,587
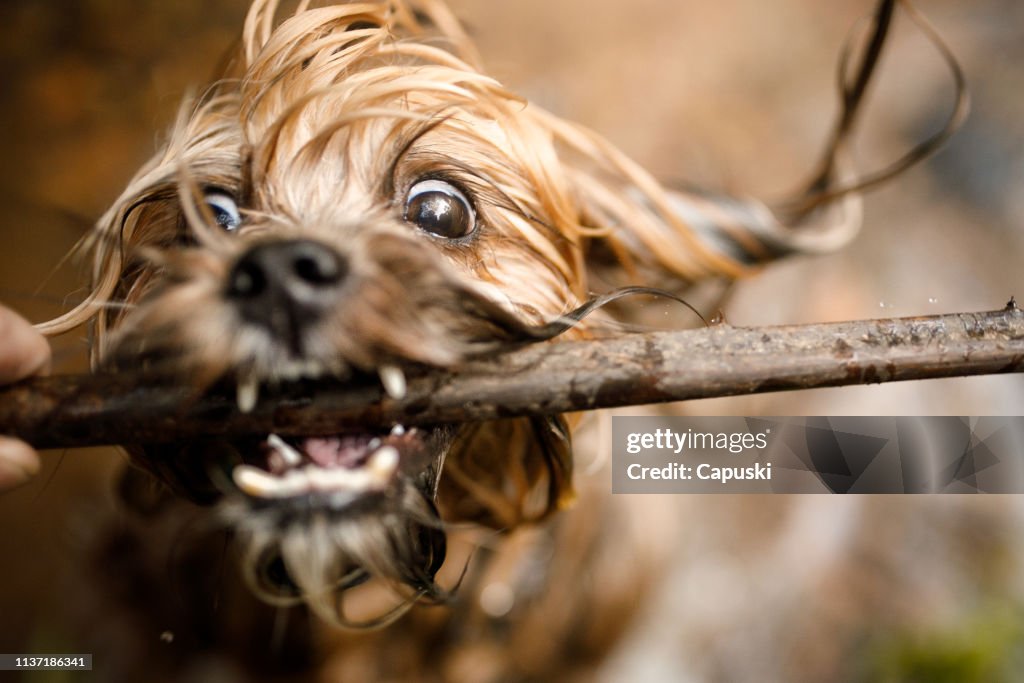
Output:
48,0,831,620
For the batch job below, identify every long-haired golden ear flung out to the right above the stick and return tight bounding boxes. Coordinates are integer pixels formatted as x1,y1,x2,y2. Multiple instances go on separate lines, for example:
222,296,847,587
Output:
535,112,861,292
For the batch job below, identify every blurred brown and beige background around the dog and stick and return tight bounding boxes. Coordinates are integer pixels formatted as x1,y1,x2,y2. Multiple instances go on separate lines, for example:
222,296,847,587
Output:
0,0,1024,681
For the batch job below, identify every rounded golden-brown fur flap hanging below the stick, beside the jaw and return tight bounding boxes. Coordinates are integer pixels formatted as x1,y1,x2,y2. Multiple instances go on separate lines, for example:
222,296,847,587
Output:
438,417,574,529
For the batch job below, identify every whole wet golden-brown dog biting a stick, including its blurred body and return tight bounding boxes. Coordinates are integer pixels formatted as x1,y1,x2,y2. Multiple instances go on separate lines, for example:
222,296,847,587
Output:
36,0,858,681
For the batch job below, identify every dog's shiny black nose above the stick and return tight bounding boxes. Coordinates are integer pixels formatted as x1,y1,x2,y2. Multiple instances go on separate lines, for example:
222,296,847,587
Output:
226,240,348,342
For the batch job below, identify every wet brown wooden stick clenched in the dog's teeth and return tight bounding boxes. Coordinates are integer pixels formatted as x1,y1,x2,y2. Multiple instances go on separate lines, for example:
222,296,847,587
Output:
0,300,1024,447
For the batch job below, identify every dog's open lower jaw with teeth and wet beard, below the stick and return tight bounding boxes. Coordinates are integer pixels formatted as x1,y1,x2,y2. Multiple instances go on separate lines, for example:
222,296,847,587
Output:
123,419,454,627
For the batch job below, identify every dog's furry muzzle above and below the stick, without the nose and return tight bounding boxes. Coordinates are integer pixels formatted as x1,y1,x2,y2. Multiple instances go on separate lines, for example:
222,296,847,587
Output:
104,226,569,626
